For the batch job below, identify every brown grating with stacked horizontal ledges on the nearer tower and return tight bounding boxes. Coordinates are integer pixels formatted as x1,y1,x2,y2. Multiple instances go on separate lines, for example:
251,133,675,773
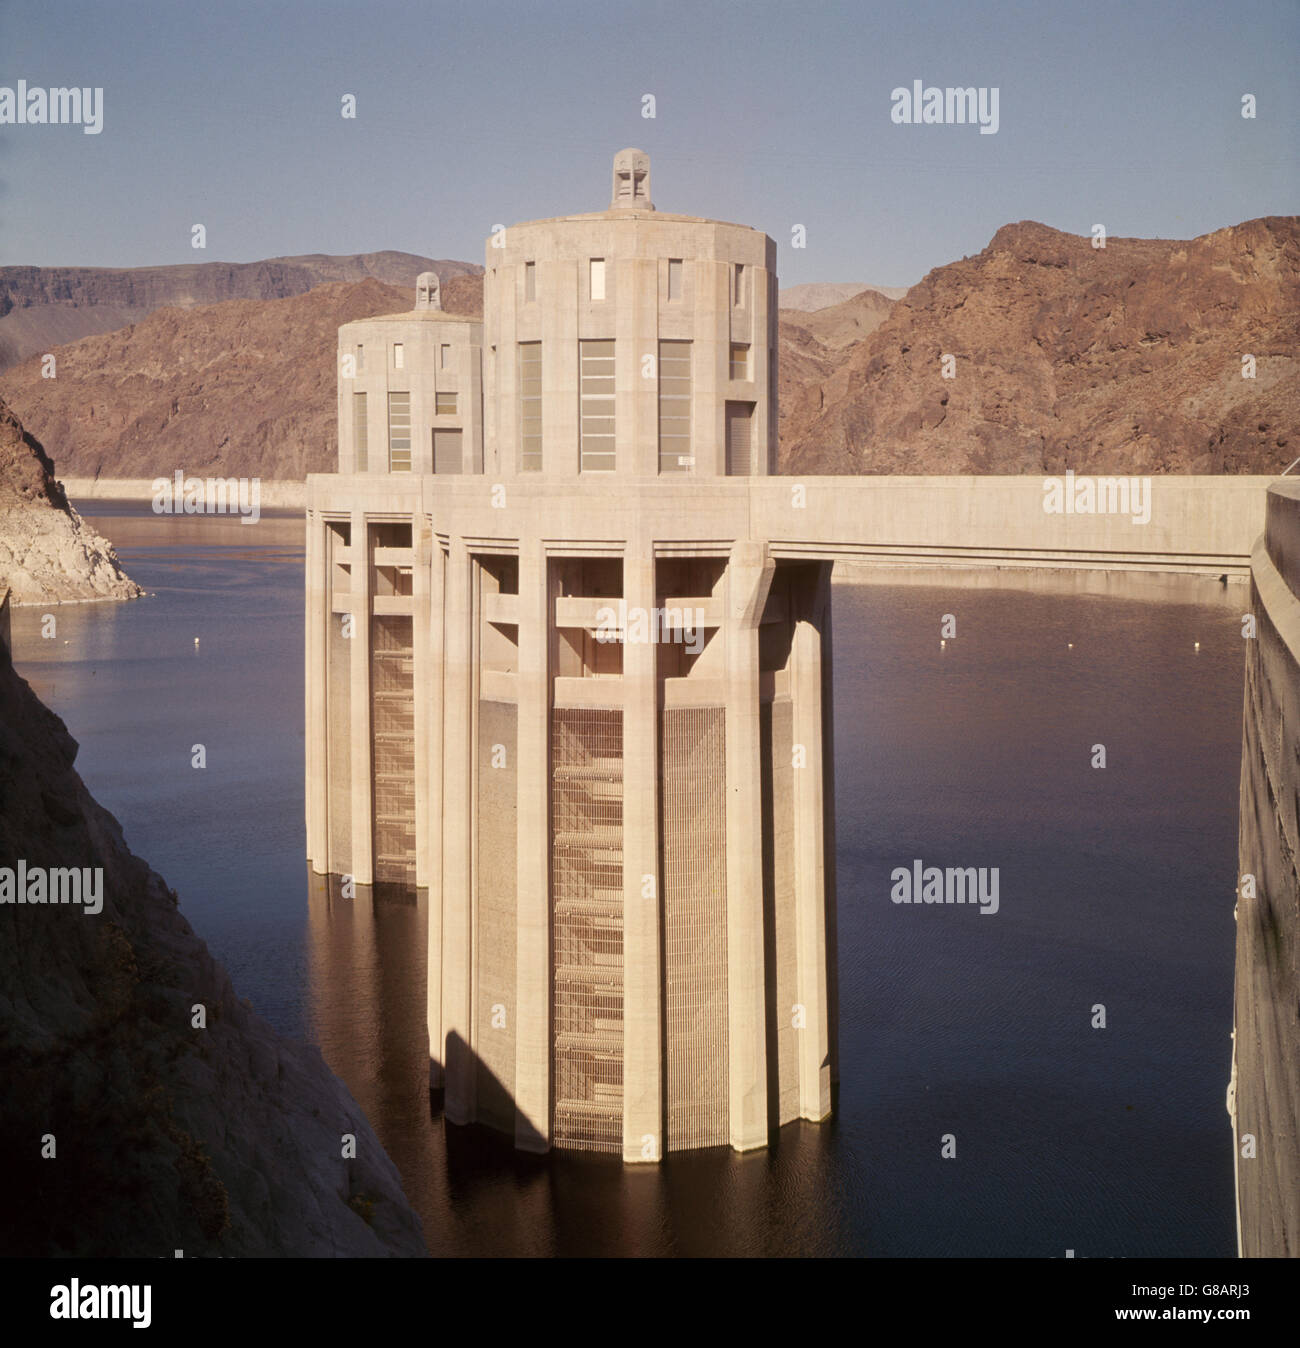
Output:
550,708,623,1154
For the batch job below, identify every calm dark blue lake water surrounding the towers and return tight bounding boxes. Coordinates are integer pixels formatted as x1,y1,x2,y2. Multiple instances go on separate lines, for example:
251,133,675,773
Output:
13,503,1247,1258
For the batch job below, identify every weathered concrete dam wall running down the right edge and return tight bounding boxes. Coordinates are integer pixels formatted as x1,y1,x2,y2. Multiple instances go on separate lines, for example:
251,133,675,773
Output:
1229,481,1300,1258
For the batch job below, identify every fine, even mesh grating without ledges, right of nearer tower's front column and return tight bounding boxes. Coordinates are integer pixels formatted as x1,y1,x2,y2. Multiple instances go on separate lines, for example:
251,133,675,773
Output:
661,706,731,1151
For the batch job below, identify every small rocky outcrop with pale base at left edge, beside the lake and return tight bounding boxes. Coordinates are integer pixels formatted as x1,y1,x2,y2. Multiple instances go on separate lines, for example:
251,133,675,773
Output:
0,399,143,604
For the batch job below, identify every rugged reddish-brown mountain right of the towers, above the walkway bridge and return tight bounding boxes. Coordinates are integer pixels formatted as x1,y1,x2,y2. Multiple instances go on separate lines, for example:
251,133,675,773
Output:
781,217,1300,473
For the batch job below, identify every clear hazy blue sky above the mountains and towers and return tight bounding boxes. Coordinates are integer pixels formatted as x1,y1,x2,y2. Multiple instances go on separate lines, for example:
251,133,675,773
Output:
0,0,1300,284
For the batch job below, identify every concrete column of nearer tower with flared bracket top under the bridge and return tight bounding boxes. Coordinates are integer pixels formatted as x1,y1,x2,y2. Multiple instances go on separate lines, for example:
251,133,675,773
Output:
724,542,775,1151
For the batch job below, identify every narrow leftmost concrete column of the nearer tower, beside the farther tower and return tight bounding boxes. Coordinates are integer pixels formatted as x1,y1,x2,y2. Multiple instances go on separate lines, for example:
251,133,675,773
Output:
428,523,446,1086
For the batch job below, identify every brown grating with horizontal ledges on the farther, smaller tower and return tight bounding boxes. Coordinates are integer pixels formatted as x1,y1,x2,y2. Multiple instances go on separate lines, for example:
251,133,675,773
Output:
371,613,415,884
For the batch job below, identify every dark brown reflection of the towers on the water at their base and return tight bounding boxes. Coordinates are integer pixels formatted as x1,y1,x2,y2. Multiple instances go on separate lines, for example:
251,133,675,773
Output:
307,874,850,1255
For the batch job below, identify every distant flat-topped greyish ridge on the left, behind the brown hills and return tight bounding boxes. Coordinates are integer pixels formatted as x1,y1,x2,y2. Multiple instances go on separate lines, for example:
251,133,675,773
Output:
0,252,483,371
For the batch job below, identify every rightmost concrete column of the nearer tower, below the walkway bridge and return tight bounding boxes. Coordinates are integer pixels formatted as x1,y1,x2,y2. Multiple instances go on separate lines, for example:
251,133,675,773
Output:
782,563,831,1122
